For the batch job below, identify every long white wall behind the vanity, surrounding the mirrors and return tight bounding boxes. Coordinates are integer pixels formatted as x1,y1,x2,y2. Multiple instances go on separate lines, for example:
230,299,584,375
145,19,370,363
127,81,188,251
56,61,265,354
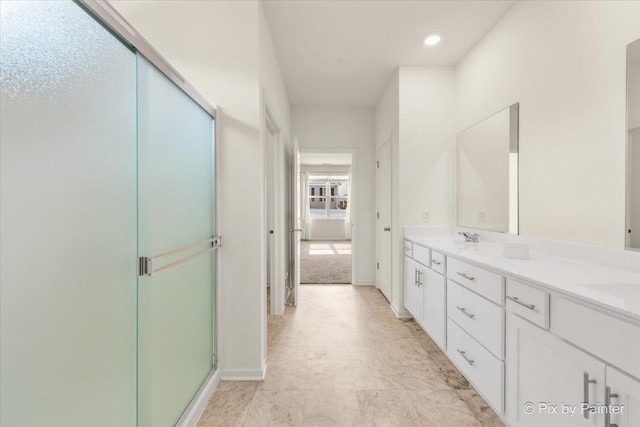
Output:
456,1,640,248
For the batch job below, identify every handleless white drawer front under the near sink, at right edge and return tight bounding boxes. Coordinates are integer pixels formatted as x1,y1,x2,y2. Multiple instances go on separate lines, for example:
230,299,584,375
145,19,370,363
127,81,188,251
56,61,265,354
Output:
550,295,640,378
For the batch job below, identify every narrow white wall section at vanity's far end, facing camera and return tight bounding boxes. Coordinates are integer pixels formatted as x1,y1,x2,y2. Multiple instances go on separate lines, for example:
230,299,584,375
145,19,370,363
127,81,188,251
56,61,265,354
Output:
398,67,456,231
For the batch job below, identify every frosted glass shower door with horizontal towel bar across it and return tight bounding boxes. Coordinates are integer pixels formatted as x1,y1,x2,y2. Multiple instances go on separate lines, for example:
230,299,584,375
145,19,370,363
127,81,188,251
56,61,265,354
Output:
138,55,215,427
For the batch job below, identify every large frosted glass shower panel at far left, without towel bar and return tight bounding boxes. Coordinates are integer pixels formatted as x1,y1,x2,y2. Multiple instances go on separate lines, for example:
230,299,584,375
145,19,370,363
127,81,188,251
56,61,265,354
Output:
0,0,137,427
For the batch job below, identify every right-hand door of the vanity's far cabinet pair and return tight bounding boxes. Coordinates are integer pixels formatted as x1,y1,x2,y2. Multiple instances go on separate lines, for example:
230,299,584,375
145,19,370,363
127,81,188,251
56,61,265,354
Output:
420,267,447,349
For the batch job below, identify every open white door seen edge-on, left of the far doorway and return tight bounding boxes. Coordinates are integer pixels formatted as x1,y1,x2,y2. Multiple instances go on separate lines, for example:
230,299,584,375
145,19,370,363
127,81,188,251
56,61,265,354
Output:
287,139,302,306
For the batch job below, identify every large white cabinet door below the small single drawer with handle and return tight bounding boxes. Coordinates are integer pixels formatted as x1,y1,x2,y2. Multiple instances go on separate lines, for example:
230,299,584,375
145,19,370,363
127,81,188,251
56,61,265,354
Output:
505,313,605,427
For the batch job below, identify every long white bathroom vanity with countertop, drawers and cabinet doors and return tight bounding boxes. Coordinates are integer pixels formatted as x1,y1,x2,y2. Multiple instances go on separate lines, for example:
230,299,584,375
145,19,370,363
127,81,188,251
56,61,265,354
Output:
404,232,640,427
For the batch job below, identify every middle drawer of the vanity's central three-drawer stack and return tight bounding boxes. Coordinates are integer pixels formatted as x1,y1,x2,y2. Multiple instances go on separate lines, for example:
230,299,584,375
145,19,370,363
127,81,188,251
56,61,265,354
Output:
447,280,504,360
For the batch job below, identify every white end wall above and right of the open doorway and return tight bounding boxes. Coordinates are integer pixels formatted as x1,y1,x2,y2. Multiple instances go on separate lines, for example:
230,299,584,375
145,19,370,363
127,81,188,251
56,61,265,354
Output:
291,106,375,284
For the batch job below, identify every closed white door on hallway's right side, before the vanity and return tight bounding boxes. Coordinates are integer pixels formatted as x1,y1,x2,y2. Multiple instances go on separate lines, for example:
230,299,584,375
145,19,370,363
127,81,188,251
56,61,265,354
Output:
376,138,391,301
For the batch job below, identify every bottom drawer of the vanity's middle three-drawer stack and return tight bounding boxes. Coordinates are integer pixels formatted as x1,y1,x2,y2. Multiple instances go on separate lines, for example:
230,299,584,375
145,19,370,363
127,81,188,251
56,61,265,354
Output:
447,319,504,413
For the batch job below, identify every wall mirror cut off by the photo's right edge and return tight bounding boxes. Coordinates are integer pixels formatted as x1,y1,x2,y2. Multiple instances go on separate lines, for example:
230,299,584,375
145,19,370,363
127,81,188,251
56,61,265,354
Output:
625,40,640,250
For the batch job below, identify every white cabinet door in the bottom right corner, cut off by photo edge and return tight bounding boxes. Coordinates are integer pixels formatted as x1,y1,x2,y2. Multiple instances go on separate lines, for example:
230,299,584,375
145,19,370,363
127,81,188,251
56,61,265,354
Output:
604,366,640,427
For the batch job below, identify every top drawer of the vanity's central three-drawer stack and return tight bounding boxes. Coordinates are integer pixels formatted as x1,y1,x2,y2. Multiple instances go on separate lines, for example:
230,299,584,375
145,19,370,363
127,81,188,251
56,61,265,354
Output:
447,257,504,305
